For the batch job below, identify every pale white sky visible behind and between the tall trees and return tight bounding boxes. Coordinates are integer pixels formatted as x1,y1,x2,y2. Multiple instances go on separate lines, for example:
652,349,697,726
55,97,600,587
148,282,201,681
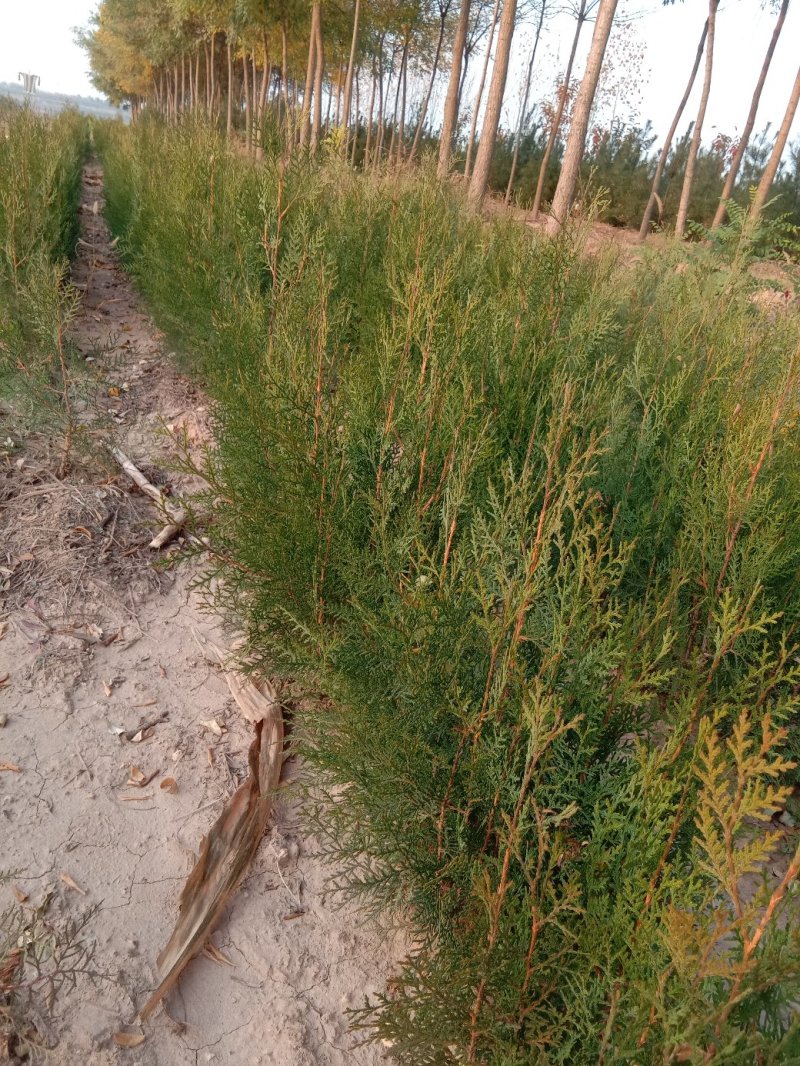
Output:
0,0,800,147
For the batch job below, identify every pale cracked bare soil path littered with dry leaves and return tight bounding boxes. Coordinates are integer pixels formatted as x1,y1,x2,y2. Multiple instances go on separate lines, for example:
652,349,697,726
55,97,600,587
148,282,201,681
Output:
0,165,400,1066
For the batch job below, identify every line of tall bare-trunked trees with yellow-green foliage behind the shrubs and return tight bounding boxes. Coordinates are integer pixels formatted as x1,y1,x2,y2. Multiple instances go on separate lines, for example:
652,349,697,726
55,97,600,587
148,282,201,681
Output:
79,0,800,239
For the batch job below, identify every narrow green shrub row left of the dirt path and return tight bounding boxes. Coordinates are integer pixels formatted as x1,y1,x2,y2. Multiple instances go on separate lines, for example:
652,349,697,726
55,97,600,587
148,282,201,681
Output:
0,101,87,466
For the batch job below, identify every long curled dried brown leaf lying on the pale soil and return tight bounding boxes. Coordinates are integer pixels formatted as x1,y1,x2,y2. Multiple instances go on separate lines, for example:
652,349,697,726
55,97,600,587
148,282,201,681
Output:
139,705,284,1021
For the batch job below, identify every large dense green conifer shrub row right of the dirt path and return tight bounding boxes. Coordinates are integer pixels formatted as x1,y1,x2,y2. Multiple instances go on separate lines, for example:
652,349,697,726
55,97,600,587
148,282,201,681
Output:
102,123,800,1066
